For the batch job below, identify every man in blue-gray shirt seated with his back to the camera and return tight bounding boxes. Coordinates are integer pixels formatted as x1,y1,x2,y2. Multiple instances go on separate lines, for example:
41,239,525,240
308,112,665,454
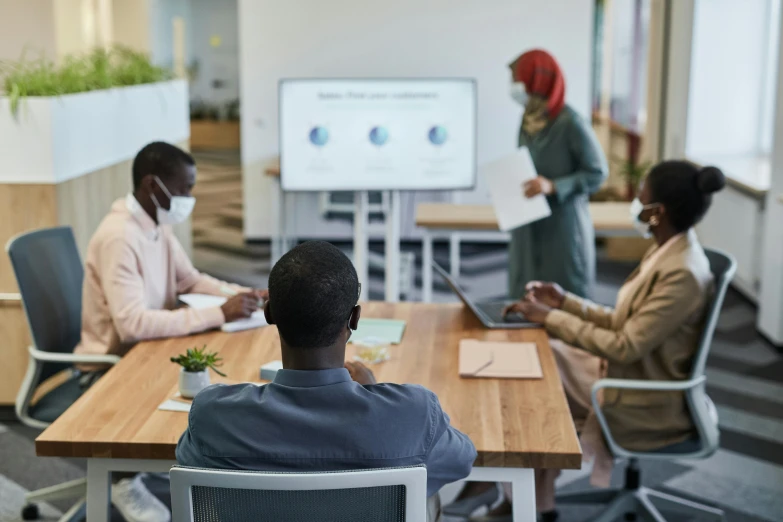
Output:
177,241,476,515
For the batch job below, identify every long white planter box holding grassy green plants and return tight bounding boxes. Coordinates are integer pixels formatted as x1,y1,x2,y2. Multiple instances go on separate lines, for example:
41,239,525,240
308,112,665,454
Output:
0,80,190,183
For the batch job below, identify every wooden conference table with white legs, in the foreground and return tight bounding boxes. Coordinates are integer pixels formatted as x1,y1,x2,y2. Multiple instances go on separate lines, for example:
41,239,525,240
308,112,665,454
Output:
35,302,582,522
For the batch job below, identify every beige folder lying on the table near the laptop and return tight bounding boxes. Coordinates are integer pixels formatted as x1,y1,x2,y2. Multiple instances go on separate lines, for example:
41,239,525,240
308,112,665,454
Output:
459,339,544,379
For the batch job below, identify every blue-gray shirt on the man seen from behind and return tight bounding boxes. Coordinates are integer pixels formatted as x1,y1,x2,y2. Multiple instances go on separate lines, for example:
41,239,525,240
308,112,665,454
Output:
177,368,476,496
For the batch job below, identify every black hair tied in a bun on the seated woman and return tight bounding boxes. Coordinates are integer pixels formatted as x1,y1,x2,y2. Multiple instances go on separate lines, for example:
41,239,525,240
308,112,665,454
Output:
645,161,726,232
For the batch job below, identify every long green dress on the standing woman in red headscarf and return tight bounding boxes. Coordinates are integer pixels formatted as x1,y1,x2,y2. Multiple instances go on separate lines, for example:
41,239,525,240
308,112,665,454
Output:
508,105,608,299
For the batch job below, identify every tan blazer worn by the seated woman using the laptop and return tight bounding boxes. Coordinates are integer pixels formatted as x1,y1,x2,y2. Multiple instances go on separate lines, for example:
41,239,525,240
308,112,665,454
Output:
546,230,713,451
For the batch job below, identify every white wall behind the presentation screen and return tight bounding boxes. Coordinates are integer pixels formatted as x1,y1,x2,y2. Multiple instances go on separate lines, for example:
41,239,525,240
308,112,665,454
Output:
239,0,593,238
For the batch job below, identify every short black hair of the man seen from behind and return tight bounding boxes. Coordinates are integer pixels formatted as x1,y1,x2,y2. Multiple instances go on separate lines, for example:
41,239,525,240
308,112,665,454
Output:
269,241,359,348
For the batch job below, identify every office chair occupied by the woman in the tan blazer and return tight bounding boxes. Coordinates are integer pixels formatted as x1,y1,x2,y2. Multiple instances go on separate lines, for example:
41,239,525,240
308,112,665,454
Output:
557,248,737,522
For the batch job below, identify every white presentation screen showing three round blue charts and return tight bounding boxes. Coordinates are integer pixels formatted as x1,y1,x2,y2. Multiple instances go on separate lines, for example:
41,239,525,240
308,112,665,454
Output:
279,79,476,191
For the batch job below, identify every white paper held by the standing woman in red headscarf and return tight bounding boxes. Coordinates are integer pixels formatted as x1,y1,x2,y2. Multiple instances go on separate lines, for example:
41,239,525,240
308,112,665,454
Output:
481,147,552,232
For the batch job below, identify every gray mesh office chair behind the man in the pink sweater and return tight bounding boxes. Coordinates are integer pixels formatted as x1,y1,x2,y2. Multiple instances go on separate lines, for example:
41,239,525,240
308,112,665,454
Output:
6,227,119,521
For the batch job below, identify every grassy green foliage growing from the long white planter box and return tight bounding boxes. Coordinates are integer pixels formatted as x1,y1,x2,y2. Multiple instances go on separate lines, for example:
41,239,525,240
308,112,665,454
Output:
0,46,173,115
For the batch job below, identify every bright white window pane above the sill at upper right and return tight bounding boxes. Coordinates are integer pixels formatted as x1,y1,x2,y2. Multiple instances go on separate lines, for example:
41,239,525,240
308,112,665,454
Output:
686,0,772,159
